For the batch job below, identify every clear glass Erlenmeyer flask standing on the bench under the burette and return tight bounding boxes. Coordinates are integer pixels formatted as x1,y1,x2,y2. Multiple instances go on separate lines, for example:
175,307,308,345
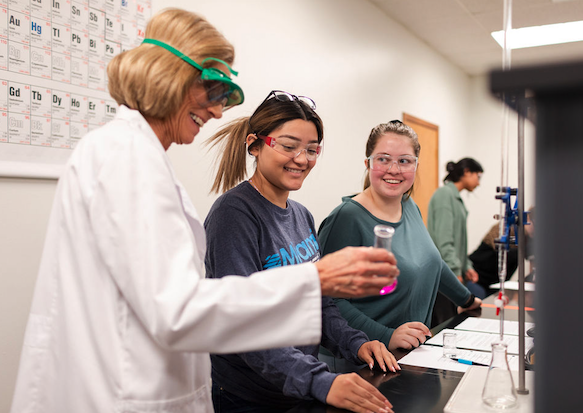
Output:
482,341,518,410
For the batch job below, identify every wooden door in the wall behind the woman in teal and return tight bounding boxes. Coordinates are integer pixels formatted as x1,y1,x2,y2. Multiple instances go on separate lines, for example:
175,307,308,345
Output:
403,113,439,226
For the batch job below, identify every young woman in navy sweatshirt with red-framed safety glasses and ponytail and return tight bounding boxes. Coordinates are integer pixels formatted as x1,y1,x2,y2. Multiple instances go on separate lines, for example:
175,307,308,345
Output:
205,90,399,413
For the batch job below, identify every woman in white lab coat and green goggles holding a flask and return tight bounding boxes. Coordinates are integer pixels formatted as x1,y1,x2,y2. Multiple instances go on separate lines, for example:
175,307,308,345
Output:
12,9,398,413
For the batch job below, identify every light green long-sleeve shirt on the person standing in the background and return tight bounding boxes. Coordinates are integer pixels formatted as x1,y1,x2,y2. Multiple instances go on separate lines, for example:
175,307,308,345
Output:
427,182,471,275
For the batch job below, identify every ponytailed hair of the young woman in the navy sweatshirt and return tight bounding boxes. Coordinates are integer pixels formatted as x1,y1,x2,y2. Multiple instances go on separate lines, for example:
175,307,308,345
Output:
206,98,324,192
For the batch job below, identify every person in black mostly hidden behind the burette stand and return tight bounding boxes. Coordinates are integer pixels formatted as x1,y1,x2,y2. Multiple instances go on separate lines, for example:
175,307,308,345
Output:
469,207,534,298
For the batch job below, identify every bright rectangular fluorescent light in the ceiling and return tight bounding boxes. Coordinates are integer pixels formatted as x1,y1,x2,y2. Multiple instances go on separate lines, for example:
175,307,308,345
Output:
492,21,583,49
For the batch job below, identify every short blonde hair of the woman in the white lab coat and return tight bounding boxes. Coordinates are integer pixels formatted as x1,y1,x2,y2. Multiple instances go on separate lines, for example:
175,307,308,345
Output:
107,8,235,119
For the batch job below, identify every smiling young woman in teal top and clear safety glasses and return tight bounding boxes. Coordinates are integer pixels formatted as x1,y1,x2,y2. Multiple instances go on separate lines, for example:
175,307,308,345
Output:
318,120,481,370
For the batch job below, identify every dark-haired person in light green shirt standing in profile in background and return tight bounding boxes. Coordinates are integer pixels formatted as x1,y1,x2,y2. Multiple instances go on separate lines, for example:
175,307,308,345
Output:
427,158,484,327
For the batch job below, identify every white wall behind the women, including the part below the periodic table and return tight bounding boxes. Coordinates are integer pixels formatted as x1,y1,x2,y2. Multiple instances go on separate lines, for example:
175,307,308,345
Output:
0,0,534,412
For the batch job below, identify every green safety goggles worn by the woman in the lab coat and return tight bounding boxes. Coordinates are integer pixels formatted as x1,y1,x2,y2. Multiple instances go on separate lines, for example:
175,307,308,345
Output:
143,39,245,109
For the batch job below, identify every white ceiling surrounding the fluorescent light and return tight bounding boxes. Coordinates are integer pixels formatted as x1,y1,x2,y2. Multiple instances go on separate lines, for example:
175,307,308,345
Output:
369,0,583,75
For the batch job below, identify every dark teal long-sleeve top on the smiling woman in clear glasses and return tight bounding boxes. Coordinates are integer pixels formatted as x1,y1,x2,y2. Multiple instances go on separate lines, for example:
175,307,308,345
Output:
318,197,470,345
